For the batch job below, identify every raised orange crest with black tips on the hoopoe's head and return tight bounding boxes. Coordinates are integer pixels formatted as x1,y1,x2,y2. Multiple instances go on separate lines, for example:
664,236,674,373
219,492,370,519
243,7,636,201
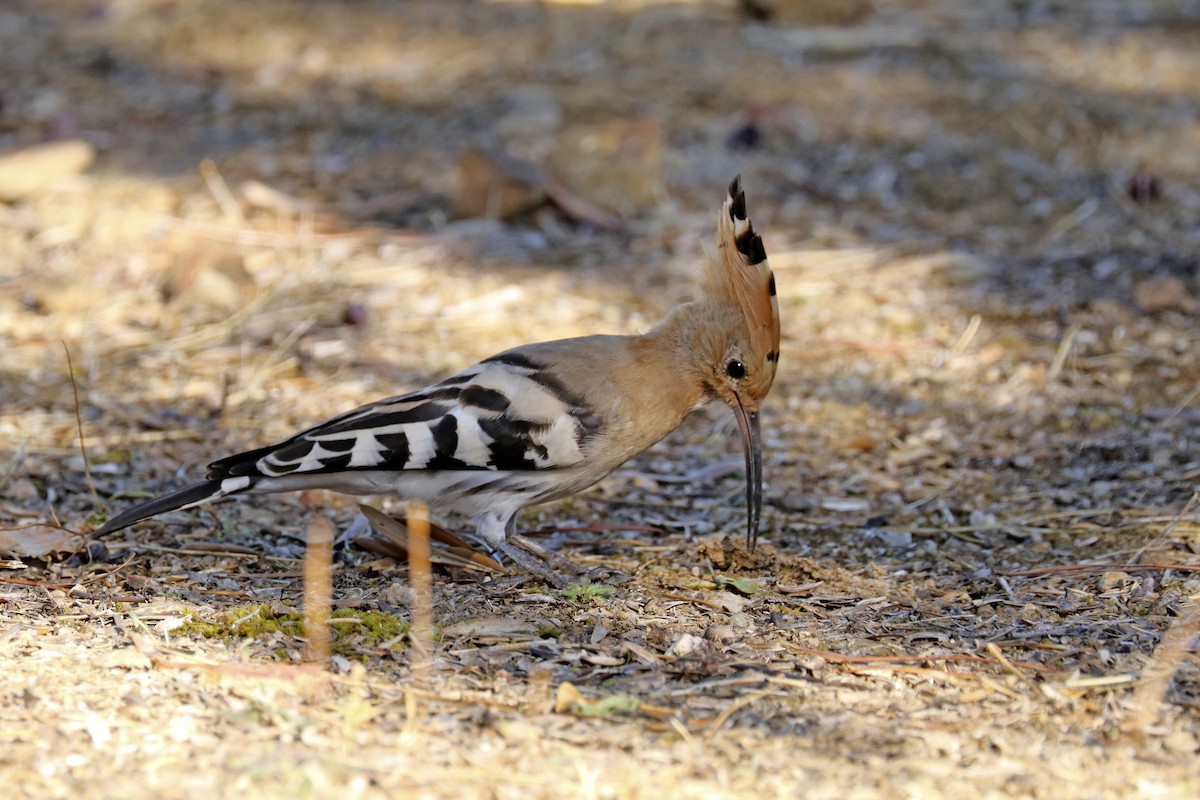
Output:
701,175,779,395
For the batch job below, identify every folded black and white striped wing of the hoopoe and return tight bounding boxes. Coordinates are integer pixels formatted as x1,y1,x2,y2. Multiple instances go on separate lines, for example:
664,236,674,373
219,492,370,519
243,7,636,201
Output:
208,351,599,491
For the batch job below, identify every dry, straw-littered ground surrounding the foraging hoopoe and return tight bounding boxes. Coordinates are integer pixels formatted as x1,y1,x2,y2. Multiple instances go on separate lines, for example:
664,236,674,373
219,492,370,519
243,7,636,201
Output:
0,0,1200,799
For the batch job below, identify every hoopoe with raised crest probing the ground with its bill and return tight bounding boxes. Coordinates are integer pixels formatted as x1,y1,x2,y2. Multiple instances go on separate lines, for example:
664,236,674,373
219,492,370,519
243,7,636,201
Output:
96,176,779,585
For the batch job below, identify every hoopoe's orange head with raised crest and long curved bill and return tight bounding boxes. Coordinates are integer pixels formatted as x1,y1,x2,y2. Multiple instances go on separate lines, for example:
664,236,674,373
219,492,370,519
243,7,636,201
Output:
701,176,779,548
